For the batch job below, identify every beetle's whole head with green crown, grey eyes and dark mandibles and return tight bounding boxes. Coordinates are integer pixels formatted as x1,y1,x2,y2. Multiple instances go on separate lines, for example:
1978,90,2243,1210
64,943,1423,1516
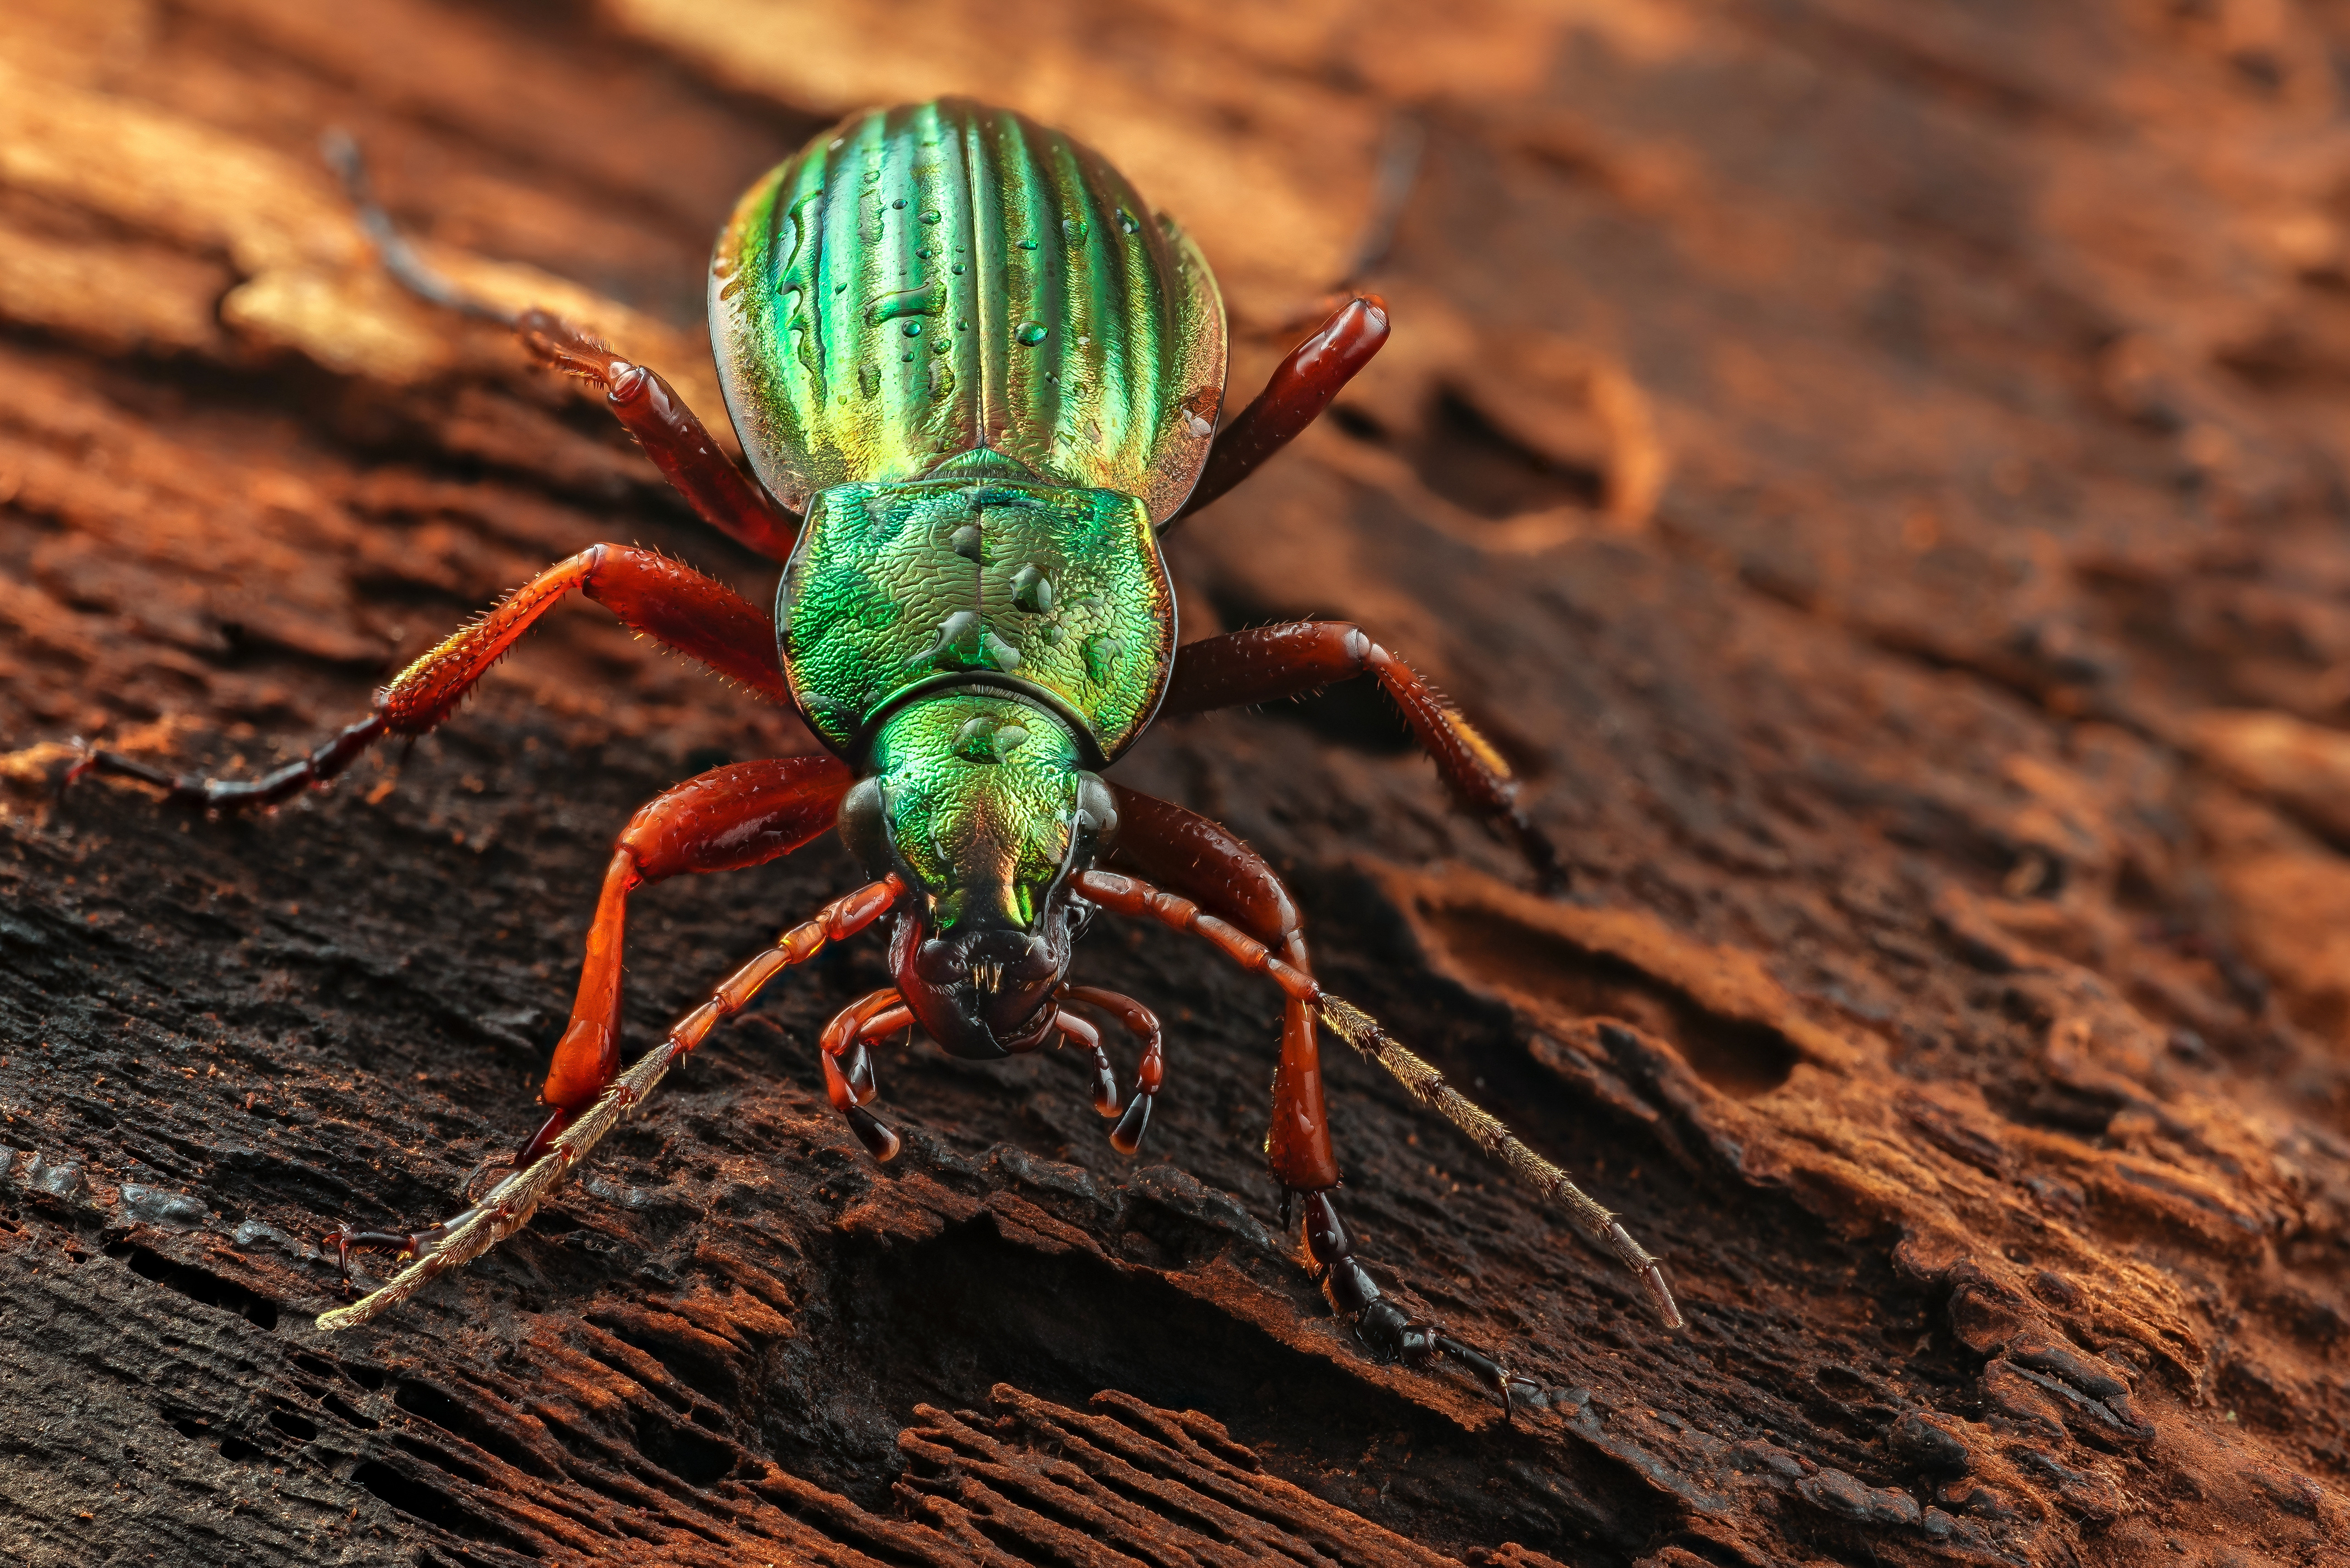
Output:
841,691,1119,1058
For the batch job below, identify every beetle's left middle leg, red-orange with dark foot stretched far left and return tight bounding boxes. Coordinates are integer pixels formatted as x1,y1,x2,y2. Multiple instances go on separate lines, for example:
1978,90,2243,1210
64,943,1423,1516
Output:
66,545,792,811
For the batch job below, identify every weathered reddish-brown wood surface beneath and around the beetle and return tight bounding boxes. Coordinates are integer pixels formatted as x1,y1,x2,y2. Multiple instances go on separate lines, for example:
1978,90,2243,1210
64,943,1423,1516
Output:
0,0,2350,1568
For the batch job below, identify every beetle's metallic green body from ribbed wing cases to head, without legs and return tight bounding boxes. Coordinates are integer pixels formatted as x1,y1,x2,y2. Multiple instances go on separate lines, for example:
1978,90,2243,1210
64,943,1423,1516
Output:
710,99,1225,992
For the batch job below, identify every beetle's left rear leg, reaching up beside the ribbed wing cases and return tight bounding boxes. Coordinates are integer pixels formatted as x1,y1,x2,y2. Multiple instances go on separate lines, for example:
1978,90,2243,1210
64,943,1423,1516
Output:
322,132,799,562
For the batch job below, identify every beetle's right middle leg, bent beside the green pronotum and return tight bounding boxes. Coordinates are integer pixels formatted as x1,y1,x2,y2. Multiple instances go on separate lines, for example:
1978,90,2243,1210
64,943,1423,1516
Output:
1161,621,1567,891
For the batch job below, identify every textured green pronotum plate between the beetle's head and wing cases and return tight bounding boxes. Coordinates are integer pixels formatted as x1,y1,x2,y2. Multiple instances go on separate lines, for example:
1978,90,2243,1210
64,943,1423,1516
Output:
776,475,1175,767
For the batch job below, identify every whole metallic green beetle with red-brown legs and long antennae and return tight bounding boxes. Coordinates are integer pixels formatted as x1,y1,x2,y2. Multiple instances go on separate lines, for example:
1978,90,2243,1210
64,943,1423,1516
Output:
73,99,1680,1411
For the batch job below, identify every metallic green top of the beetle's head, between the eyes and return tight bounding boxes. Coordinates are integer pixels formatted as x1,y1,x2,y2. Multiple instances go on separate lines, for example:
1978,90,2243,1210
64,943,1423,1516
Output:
872,689,1083,933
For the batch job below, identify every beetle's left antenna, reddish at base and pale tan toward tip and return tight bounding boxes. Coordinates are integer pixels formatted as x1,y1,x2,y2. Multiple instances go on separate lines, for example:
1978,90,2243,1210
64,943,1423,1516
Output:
317,877,905,1333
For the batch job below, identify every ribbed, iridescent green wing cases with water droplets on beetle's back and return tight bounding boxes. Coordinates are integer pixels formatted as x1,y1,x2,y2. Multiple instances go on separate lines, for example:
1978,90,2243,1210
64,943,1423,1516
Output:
710,99,1225,524
